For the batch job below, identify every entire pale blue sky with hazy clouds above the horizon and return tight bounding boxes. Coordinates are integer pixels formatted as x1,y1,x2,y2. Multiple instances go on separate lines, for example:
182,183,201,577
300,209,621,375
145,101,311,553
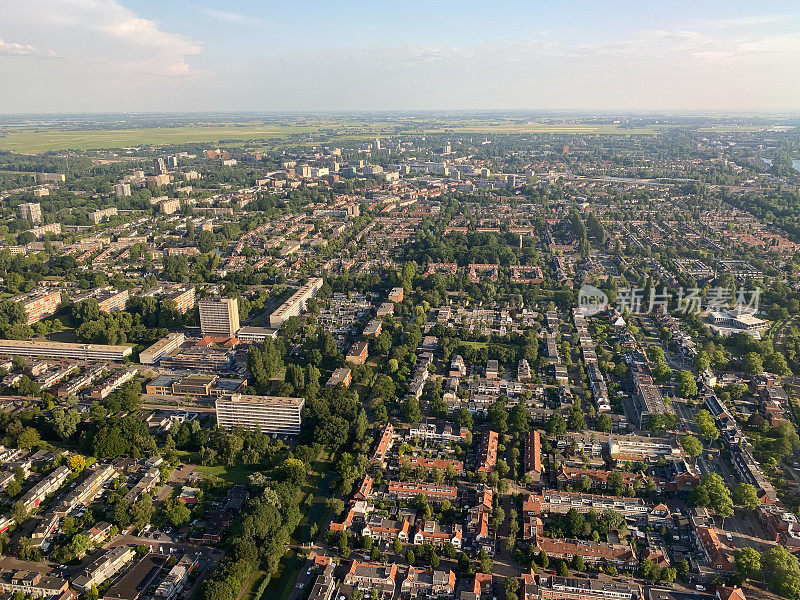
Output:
0,0,800,113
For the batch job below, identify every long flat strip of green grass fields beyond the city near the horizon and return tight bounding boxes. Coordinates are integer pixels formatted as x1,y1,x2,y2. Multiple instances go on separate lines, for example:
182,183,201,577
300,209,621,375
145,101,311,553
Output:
0,120,664,154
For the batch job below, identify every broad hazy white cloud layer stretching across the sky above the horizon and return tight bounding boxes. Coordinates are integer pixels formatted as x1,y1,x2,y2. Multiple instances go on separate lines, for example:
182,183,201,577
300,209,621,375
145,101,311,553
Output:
0,0,800,111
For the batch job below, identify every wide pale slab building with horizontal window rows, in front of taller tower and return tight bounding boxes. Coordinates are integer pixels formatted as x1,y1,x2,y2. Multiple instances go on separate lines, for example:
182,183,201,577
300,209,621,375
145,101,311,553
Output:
216,394,305,435
